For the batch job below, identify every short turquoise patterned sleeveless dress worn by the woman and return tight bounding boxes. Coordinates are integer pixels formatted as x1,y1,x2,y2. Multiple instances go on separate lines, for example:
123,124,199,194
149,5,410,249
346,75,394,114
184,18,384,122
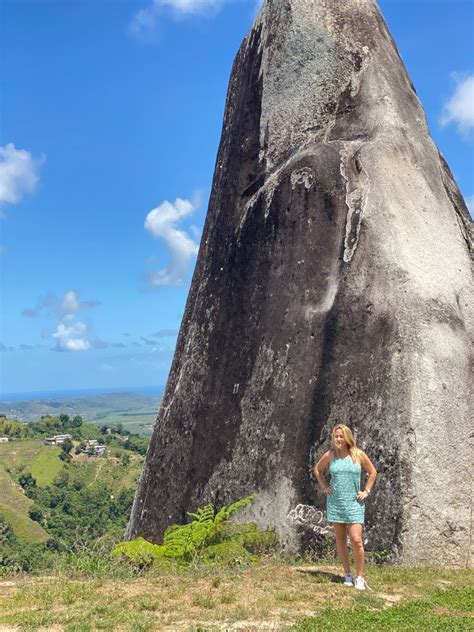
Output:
326,456,365,524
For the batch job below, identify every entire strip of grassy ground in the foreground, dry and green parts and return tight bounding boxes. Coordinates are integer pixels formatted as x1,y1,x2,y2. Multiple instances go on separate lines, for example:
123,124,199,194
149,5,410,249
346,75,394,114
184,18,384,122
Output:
0,560,474,632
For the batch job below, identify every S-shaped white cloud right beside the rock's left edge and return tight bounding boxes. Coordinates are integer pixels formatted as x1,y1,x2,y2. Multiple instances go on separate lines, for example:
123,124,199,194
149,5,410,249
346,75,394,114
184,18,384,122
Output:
145,198,199,287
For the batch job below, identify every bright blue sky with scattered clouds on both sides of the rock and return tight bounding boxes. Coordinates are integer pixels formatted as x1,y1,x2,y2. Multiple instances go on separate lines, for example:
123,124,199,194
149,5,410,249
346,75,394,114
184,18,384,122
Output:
0,0,474,393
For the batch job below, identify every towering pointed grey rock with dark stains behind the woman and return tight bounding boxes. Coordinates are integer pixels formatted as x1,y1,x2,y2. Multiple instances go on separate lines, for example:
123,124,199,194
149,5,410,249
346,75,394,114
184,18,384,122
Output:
127,0,472,566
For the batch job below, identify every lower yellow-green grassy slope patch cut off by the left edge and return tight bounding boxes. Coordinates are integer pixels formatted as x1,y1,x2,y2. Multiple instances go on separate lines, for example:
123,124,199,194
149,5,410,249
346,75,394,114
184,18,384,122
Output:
0,468,50,544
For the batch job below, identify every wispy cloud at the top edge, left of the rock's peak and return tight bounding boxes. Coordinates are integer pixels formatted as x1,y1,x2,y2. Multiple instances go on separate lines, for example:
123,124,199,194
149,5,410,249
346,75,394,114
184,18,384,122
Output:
129,0,231,39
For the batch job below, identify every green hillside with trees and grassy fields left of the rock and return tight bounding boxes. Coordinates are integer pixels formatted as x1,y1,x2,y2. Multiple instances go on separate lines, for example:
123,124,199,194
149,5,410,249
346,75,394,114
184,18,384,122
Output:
0,414,147,575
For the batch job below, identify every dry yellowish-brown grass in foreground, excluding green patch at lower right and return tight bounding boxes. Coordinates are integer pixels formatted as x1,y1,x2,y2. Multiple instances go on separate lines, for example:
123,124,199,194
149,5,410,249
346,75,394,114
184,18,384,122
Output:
0,563,473,632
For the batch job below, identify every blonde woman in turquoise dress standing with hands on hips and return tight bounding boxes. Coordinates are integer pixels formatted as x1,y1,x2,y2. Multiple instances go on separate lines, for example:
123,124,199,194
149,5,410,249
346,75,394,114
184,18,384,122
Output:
314,424,377,590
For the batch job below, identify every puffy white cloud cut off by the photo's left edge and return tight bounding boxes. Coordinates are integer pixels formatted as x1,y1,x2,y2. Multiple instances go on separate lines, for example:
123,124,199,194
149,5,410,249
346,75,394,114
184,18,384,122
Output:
0,143,44,204
